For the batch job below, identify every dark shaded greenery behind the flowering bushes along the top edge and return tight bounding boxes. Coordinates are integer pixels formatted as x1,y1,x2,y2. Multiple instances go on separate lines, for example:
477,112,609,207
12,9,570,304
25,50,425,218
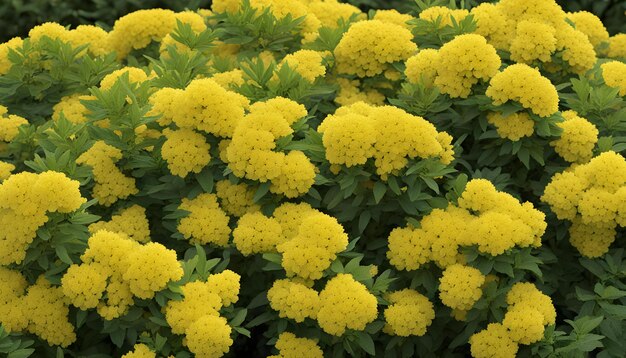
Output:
0,0,626,42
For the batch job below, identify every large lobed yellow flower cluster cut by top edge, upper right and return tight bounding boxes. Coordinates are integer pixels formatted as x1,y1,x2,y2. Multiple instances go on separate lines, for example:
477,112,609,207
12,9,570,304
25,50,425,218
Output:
471,0,596,74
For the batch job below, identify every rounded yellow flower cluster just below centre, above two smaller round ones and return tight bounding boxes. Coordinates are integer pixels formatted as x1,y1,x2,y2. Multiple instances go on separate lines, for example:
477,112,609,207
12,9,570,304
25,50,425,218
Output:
274,204,348,280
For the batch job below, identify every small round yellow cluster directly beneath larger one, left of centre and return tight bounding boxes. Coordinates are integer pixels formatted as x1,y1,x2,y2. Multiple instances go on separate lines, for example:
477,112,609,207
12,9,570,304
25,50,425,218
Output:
161,128,211,178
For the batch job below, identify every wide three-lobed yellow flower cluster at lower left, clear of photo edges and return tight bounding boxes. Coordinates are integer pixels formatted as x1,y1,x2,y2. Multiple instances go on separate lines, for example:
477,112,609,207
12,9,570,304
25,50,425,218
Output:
61,230,183,320
